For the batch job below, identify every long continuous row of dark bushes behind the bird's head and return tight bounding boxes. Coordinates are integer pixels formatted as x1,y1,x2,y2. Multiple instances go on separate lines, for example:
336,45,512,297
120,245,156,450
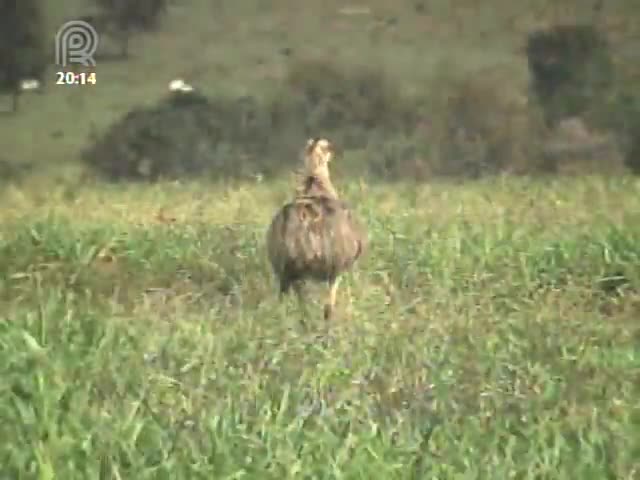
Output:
83,54,624,184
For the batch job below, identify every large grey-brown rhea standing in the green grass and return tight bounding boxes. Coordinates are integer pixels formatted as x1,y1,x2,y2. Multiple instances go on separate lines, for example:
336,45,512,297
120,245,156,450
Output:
267,139,366,318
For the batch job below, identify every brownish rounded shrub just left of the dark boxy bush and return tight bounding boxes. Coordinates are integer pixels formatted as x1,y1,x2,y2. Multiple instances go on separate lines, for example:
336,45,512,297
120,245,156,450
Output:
431,68,546,177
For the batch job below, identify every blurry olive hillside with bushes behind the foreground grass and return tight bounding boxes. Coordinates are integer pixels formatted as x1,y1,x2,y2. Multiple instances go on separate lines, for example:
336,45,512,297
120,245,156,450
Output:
0,0,640,180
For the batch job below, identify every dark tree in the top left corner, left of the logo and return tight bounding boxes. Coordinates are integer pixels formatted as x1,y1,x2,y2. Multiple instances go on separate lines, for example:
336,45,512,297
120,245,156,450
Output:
0,0,48,108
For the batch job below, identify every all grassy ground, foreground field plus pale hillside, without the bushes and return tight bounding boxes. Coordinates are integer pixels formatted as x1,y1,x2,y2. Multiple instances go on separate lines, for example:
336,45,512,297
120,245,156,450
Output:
0,0,640,480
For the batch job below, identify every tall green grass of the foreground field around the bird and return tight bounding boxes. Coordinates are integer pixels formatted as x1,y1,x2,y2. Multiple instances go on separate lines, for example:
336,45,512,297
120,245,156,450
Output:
0,178,640,479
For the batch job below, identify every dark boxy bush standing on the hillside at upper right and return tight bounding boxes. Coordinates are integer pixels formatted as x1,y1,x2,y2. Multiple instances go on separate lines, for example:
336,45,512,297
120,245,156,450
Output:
526,25,614,125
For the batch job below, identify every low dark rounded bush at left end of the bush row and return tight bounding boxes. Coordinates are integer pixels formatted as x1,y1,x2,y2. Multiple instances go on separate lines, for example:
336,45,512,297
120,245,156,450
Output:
83,92,290,180
